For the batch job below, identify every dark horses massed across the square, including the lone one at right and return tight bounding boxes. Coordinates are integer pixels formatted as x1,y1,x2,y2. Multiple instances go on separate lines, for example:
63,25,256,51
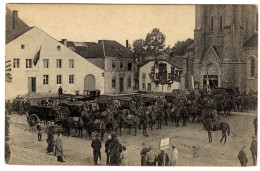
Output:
56,91,230,142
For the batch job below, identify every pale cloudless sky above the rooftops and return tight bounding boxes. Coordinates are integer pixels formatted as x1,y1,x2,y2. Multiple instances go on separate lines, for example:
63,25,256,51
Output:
7,4,195,47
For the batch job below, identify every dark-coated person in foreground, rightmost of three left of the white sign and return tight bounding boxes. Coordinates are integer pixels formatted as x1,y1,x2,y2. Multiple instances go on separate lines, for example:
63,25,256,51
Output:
109,134,122,166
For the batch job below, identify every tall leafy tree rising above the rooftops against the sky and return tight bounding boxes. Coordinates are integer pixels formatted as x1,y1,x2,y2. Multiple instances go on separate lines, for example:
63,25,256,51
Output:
144,28,166,56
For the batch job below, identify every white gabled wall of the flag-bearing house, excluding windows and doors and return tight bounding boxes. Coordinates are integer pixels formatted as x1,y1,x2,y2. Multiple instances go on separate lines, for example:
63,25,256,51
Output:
6,27,104,97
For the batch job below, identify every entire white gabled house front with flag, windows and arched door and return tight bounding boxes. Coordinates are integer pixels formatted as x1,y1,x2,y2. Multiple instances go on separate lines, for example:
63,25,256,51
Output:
6,27,104,98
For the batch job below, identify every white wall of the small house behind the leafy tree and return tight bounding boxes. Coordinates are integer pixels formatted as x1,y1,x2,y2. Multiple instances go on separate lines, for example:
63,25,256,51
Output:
139,61,181,92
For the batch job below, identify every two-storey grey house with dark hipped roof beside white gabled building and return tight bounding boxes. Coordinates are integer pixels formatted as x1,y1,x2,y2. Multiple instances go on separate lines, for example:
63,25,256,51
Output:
74,40,134,95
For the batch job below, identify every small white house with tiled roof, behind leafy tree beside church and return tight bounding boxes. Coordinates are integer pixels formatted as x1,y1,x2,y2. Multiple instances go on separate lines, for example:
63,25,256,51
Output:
138,56,182,92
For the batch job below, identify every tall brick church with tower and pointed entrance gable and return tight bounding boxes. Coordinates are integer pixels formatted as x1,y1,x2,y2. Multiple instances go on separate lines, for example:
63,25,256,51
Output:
183,5,258,92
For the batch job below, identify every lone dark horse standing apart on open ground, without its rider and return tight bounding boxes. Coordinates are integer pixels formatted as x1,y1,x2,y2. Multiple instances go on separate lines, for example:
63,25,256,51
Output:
201,119,230,144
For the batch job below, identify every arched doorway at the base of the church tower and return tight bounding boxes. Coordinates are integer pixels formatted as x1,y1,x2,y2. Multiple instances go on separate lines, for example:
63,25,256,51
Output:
203,63,219,88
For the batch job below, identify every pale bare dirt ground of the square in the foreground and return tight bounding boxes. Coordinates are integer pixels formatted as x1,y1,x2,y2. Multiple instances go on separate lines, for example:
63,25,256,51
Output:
6,115,254,166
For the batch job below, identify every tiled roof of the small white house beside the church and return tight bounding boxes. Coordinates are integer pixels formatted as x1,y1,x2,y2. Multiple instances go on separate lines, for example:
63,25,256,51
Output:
137,55,183,69
